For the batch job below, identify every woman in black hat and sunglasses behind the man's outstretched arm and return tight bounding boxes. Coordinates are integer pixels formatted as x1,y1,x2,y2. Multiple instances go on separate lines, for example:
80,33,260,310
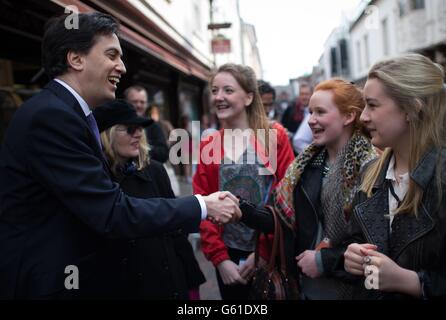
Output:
94,100,206,299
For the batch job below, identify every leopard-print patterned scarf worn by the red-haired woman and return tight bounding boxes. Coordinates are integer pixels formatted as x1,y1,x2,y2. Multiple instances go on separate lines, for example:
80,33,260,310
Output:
274,131,377,229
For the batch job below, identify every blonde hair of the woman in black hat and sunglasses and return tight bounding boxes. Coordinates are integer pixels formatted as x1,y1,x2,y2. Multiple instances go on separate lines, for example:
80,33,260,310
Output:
101,125,150,174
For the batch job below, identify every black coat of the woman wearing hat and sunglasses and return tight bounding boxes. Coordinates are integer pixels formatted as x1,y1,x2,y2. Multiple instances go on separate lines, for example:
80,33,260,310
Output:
98,160,206,299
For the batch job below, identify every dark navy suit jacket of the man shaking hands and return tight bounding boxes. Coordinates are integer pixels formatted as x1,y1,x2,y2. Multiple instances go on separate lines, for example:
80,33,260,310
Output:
0,81,201,299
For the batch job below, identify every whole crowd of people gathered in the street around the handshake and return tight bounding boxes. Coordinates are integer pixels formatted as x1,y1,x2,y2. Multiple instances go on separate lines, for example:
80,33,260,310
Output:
0,13,446,300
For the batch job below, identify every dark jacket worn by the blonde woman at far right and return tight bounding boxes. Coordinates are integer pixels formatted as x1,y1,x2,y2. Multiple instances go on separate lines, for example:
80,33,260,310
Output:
352,149,446,299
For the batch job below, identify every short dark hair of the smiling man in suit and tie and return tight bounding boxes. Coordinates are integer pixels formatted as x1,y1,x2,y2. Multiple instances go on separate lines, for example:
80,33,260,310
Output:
42,12,119,78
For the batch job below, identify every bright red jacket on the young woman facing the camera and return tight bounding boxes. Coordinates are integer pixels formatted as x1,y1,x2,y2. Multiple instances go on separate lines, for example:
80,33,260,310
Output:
192,123,294,266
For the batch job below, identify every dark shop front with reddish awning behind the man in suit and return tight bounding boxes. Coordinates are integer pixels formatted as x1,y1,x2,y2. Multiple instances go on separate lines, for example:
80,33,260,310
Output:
0,0,213,141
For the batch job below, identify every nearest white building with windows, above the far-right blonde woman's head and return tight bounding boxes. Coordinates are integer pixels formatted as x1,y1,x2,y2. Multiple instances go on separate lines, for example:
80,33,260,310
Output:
350,0,446,81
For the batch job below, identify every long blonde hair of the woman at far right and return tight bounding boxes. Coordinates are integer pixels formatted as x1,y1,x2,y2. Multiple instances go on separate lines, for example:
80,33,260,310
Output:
361,54,446,215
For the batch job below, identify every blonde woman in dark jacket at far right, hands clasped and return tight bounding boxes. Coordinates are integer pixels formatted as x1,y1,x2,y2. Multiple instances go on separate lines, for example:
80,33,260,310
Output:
344,54,446,299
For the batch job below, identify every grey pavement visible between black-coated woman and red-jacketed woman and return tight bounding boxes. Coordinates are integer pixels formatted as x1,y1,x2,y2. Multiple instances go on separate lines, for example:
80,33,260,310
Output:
178,178,221,300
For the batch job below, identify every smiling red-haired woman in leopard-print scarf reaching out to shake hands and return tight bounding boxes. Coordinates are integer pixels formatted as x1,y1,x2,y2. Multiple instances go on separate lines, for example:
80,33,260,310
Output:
240,79,376,300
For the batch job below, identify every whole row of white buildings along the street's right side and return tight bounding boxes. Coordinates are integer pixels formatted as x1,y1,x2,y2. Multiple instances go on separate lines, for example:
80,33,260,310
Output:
312,0,446,83
